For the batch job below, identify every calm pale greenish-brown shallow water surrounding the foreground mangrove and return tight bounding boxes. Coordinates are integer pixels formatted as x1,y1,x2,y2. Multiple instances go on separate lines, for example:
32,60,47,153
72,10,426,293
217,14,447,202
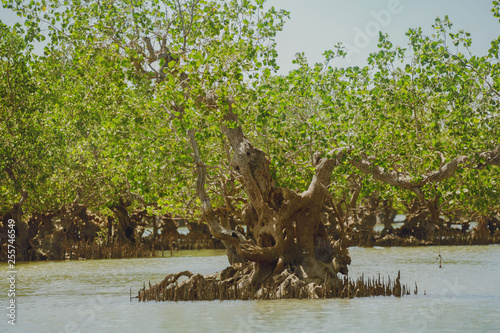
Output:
0,245,500,332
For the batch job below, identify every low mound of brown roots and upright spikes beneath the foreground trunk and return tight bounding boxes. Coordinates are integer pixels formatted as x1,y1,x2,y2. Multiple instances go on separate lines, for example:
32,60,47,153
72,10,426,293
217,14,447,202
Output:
136,264,417,302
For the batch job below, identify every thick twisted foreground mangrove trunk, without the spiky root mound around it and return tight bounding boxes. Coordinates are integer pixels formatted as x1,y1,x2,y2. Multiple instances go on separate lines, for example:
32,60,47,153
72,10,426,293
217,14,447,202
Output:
166,114,350,297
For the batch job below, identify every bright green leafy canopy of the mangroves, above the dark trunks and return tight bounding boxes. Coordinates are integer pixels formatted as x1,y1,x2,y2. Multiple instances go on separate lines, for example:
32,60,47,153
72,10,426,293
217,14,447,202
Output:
0,0,500,228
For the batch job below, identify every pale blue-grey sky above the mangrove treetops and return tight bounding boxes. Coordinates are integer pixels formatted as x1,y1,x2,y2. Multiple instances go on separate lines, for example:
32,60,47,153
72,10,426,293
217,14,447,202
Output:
0,0,500,73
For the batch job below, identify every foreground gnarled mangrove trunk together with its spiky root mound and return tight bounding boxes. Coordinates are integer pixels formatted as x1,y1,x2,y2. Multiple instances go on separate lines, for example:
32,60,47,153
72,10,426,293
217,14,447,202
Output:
138,114,409,301
